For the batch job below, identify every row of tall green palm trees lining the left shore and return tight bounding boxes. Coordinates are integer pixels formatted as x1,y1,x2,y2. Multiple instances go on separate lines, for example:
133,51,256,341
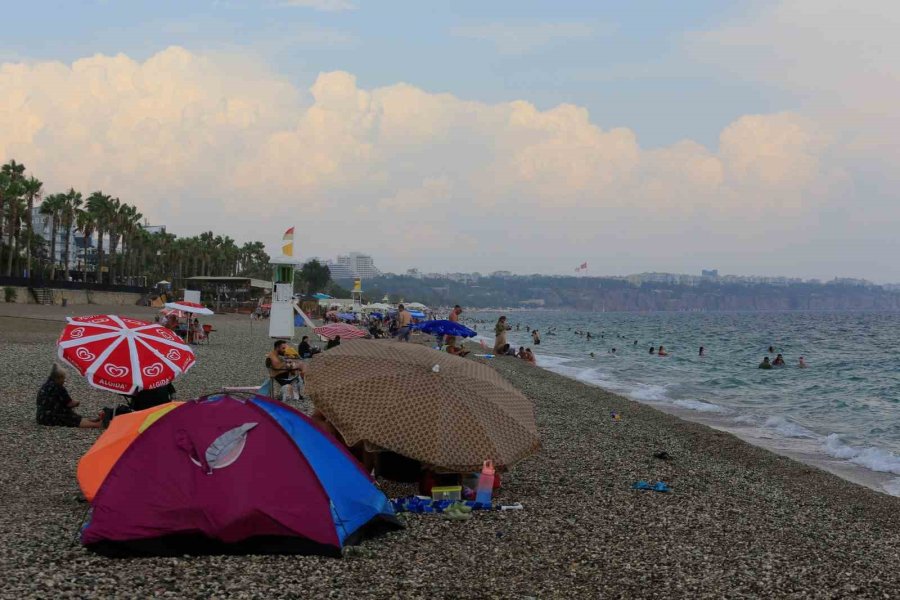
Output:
0,160,269,283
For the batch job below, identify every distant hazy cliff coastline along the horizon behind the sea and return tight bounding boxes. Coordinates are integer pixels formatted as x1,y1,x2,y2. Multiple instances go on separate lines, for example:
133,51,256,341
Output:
354,276,900,312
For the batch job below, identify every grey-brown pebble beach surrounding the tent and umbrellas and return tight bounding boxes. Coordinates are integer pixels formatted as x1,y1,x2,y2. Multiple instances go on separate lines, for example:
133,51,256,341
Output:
0,304,900,599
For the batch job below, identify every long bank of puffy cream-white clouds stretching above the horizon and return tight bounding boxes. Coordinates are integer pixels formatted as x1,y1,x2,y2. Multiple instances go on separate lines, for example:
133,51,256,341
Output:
0,47,884,272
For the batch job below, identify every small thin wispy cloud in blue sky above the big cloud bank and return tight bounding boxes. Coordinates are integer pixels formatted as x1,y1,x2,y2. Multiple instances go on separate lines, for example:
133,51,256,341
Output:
451,22,611,54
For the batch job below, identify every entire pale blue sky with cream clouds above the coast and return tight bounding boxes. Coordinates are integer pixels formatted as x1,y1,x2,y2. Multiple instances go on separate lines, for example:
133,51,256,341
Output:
0,0,900,282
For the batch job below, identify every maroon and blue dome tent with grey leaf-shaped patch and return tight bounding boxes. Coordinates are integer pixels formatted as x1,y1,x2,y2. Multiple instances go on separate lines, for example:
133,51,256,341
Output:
79,394,400,556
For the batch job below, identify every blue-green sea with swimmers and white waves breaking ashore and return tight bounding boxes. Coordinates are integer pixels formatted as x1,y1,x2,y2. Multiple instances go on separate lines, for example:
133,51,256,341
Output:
463,310,900,496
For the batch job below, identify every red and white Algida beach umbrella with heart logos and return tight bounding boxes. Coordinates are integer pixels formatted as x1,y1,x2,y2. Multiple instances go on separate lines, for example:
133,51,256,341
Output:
57,315,195,394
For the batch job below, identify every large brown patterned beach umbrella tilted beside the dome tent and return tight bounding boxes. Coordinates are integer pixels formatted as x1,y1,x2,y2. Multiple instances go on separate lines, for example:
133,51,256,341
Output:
304,340,540,472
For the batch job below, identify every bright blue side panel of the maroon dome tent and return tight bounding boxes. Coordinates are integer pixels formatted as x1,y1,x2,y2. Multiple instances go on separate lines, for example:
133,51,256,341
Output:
253,398,394,544
